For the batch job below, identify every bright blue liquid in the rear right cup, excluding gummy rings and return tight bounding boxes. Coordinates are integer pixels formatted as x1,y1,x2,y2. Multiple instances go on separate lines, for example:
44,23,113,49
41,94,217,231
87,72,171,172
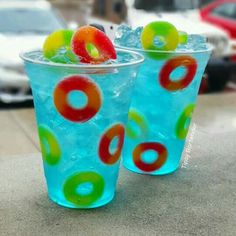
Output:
122,51,210,175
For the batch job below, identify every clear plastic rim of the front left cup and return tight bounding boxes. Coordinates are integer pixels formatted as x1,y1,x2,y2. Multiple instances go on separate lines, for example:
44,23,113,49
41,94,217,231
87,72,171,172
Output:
20,48,145,70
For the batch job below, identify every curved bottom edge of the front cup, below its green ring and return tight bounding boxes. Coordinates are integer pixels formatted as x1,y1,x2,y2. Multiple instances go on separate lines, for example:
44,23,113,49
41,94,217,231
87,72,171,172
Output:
48,194,114,209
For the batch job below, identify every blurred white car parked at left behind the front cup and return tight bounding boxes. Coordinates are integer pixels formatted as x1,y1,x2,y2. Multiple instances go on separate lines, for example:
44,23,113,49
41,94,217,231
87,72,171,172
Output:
0,1,66,103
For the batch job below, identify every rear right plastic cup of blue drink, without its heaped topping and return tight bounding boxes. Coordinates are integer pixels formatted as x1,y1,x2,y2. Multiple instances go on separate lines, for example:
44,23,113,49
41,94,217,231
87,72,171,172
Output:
118,45,212,175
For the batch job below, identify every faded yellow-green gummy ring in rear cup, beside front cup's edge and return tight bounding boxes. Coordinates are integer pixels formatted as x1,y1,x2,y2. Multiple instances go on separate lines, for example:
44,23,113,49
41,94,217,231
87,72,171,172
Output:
126,108,148,139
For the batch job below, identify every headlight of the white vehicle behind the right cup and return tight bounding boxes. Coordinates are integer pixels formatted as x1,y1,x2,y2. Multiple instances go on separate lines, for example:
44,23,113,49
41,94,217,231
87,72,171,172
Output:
207,36,229,57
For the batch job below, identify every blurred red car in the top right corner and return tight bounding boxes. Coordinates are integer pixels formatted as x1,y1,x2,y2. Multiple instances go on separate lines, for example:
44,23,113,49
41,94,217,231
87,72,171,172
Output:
200,0,236,39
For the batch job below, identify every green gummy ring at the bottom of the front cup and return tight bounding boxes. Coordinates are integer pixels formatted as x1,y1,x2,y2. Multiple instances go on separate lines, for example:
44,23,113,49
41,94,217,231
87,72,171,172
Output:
63,171,105,207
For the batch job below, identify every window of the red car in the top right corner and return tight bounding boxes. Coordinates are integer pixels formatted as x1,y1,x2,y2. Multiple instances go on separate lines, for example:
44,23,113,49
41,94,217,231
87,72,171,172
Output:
212,3,236,20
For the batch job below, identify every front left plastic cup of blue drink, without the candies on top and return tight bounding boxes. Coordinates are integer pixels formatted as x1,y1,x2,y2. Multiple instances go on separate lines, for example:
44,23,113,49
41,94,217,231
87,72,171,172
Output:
21,50,144,208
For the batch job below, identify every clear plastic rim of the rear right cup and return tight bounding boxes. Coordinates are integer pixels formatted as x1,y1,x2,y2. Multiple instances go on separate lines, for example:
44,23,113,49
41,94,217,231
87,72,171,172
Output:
114,43,214,55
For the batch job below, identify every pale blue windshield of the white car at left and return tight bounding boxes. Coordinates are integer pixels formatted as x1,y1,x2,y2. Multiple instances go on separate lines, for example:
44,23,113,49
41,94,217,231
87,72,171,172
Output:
0,8,65,34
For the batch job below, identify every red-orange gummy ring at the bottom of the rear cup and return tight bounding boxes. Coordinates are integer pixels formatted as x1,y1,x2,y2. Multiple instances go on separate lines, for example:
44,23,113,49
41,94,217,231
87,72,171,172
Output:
133,142,167,172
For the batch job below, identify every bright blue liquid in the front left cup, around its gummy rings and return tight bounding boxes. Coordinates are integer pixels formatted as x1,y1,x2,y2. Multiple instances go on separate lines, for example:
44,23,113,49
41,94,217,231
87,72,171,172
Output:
25,53,140,208
